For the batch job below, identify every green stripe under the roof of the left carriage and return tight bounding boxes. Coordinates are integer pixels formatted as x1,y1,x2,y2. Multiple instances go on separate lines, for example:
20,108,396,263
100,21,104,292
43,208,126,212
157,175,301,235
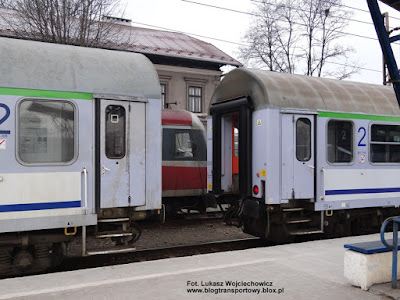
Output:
0,87,93,100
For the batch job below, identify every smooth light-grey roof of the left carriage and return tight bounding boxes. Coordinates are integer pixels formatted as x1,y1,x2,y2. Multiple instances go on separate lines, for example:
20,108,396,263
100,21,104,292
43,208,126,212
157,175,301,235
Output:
0,38,161,99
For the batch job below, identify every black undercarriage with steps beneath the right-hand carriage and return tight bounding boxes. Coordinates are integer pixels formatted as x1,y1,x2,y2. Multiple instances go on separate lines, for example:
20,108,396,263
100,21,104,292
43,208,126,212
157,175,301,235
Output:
225,199,400,243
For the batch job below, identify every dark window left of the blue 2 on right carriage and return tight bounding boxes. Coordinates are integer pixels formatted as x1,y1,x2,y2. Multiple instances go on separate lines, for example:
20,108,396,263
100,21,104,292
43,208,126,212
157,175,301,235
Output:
328,120,353,163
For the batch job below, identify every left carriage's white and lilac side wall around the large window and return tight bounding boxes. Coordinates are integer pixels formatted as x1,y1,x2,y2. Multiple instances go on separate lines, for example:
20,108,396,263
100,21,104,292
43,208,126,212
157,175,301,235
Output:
0,95,97,232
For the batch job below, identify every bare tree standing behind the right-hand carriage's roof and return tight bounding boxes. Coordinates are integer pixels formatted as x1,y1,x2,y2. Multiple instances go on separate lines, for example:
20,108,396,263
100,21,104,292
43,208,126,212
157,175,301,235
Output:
240,0,358,79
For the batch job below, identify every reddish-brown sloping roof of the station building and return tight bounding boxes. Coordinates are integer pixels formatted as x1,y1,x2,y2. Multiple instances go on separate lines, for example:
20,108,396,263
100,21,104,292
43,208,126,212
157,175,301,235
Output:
0,9,242,67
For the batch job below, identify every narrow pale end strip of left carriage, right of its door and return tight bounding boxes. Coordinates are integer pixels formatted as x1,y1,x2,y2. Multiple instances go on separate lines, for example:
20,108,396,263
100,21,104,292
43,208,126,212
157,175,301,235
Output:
135,99,162,211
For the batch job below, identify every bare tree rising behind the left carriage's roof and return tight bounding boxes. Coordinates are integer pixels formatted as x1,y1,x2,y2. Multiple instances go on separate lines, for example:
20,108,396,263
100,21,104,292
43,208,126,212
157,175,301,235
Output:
0,0,126,47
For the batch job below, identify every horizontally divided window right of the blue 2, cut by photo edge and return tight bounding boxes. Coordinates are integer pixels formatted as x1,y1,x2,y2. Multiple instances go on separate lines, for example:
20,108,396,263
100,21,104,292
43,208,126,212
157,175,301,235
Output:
370,124,400,163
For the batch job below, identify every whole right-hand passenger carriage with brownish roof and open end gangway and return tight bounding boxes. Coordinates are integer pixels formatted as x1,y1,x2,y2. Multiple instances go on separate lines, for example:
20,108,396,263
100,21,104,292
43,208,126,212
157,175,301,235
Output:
207,69,400,238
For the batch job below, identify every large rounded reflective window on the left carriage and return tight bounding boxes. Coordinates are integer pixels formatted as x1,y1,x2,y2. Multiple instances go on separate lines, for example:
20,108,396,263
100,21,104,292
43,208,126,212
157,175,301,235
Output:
18,100,77,164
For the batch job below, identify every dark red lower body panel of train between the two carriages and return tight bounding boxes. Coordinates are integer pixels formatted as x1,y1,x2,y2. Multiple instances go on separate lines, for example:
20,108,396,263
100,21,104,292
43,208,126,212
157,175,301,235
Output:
162,166,207,191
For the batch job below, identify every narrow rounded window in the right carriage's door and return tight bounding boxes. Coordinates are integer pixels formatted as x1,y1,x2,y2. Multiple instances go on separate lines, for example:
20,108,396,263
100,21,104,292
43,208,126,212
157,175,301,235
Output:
296,118,311,161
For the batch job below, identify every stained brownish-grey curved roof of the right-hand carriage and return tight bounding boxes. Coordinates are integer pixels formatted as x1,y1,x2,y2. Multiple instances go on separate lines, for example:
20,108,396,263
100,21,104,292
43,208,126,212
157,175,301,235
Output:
211,68,400,115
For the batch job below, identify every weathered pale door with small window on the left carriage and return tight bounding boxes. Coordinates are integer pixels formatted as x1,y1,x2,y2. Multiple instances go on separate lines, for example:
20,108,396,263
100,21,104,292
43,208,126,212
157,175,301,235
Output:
100,100,146,208
